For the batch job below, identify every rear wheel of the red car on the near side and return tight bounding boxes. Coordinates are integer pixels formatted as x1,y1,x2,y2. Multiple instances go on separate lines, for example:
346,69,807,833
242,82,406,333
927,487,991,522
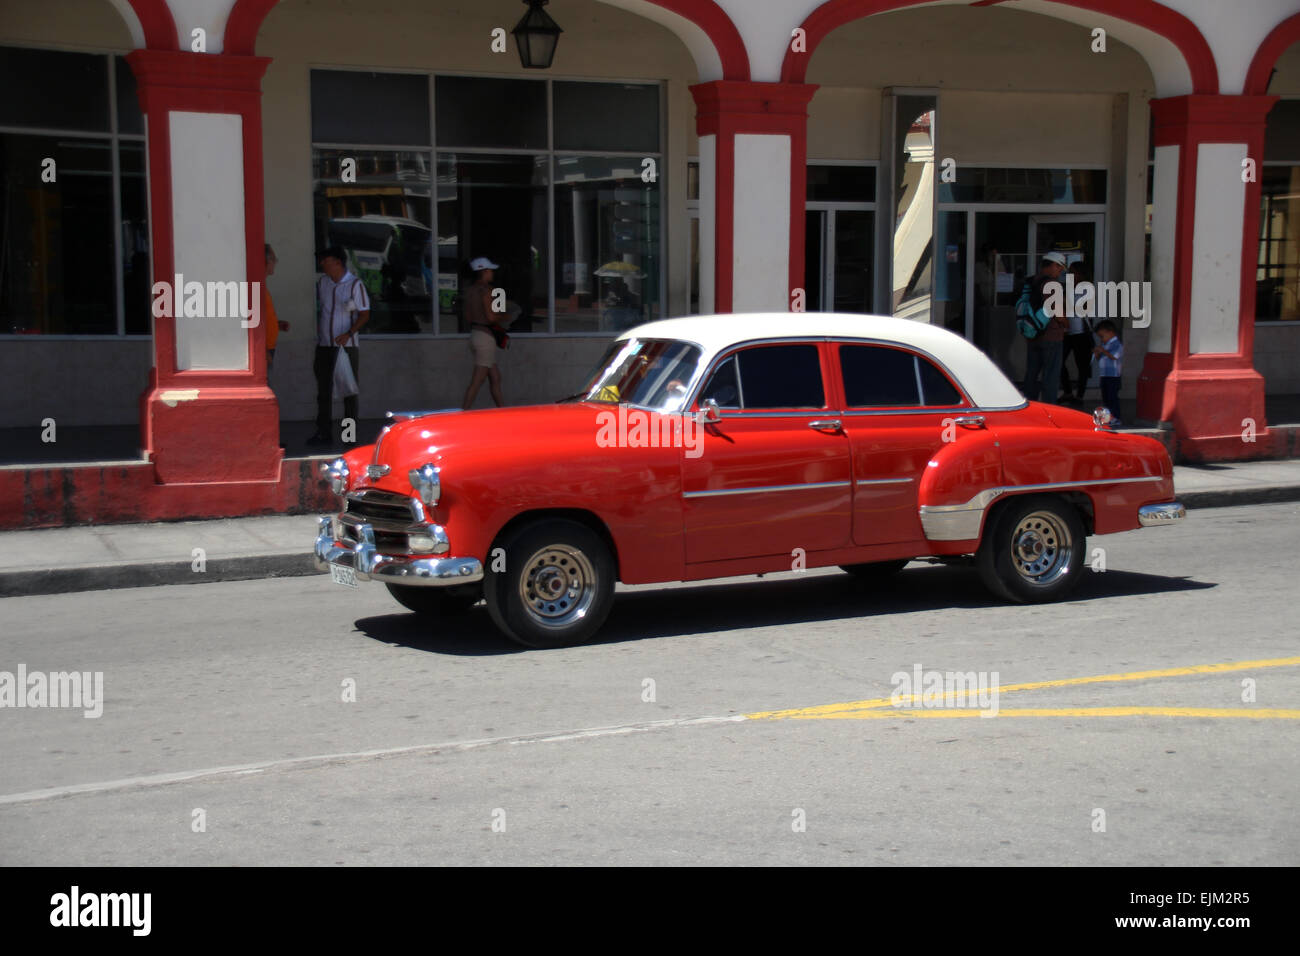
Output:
975,494,1087,604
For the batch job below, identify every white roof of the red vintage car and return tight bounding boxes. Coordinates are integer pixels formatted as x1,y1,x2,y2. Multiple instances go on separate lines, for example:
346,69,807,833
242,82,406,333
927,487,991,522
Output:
619,312,1026,408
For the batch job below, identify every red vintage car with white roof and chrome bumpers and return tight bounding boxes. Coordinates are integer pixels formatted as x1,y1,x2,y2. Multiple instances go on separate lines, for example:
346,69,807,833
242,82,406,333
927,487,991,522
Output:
316,313,1186,646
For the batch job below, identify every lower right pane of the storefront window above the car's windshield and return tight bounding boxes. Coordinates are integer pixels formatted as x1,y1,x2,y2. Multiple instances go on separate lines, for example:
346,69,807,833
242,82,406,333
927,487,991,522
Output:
555,156,659,332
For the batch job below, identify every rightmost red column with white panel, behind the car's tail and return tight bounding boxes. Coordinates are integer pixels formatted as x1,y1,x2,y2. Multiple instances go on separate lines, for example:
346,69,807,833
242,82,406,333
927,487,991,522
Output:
1138,95,1278,460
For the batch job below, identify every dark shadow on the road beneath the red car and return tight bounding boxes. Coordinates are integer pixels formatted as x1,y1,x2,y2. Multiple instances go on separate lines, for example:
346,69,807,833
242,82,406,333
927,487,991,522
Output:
356,563,1218,657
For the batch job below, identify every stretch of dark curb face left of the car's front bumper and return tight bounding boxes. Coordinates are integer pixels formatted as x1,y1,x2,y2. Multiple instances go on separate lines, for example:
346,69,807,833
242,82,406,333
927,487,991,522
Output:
0,551,322,597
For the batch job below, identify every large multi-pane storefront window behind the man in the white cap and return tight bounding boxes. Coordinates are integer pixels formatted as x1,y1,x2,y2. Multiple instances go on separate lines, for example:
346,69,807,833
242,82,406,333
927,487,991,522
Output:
312,70,664,334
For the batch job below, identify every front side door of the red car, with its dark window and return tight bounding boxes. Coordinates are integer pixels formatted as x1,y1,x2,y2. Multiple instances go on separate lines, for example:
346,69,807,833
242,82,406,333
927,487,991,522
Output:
683,342,852,564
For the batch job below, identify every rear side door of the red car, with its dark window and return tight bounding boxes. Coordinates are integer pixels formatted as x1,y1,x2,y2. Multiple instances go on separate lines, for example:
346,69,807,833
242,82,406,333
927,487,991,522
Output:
836,342,974,545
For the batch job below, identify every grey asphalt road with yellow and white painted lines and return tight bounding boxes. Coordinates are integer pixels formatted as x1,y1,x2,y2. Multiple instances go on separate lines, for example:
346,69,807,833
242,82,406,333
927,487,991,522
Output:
0,503,1300,866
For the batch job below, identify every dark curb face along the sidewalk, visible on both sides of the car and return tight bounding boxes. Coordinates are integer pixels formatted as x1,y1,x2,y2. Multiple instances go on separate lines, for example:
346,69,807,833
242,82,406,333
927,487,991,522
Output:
0,485,1300,597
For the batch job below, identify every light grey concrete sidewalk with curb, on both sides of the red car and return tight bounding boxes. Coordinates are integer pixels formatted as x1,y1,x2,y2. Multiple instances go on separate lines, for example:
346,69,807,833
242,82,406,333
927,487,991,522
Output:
0,459,1300,597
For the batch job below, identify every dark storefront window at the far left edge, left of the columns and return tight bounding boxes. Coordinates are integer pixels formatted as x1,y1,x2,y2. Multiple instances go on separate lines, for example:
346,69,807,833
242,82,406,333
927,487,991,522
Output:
0,47,151,336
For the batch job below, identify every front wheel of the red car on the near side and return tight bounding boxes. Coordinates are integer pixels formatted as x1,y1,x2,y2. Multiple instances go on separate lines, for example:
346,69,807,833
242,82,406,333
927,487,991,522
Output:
484,518,616,648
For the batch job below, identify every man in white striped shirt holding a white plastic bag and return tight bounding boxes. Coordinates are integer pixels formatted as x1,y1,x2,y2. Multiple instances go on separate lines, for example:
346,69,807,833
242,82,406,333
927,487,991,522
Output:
307,246,371,445
